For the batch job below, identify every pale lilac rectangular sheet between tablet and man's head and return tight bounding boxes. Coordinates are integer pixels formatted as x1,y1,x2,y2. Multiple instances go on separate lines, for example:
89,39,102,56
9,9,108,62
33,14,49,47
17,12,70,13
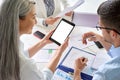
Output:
73,12,98,27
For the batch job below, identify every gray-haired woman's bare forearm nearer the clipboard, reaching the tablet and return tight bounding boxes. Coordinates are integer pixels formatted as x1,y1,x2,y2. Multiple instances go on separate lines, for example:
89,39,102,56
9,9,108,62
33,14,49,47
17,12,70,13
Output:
47,39,68,72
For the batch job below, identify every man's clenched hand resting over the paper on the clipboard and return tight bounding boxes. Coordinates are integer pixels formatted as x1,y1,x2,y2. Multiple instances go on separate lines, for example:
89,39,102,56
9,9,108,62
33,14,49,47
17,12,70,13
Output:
75,57,88,72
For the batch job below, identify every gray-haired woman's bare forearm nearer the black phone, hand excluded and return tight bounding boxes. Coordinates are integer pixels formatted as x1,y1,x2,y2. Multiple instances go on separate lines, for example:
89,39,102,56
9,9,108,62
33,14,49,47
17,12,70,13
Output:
28,41,46,57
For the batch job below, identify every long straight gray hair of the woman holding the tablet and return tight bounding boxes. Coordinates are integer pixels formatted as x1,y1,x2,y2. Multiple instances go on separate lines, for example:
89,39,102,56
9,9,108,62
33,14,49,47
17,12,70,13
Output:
0,0,35,80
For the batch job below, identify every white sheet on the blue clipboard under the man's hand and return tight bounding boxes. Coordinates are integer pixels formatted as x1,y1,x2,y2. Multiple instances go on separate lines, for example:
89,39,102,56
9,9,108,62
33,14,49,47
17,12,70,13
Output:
62,47,95,75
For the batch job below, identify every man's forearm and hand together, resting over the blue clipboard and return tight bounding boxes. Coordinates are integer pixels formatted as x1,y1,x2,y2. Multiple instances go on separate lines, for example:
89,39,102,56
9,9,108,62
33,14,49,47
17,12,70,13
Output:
73,57,88,80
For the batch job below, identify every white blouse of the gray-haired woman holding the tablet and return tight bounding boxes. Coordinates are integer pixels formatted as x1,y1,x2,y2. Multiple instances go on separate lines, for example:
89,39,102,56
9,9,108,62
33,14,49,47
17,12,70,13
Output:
19,42,53,80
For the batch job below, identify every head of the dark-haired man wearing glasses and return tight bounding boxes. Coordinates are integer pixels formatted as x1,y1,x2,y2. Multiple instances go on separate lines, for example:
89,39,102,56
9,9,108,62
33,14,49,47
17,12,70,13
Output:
97,0,120,44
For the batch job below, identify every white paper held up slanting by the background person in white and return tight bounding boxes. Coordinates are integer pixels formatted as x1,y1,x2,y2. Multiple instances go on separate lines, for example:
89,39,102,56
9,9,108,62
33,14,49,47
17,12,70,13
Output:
57,0,84,17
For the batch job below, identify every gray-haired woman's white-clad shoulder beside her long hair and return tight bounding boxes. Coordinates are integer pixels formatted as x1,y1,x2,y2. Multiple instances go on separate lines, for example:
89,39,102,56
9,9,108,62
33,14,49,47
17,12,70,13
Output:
20,55,44,80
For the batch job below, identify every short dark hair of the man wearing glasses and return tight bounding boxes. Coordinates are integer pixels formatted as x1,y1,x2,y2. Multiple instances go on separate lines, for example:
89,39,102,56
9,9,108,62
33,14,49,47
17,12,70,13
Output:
97,0,120,32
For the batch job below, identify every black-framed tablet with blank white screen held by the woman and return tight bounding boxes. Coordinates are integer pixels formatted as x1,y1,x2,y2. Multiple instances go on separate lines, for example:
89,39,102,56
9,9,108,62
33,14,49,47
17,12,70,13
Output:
50,19,75,46
